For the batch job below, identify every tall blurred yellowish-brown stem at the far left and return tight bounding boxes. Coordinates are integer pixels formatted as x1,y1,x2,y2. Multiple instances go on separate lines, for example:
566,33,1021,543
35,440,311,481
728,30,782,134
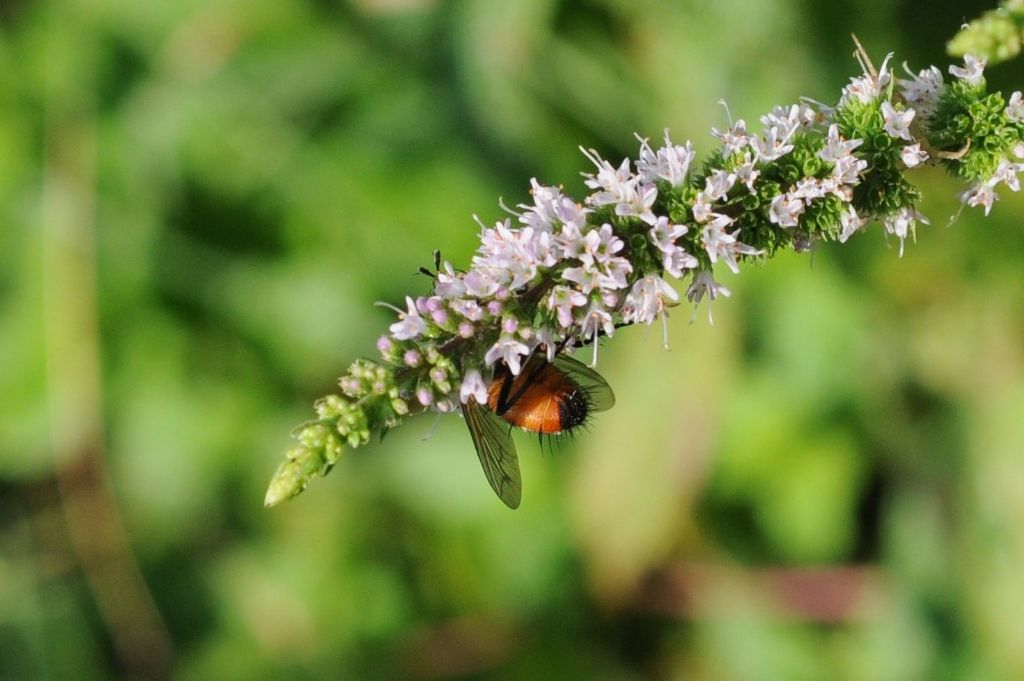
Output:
41,3,171,678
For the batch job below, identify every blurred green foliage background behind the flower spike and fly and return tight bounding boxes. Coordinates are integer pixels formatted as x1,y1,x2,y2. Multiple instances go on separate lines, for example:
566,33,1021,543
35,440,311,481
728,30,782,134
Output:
0,0,1024,681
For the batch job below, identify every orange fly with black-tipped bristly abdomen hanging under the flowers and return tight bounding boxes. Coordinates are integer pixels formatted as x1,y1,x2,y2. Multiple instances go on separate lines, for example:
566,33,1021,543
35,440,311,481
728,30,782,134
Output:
462,353,615,509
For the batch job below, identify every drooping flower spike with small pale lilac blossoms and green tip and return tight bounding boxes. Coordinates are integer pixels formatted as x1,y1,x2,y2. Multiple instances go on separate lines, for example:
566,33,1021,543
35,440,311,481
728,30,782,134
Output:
265,50,1024,506
